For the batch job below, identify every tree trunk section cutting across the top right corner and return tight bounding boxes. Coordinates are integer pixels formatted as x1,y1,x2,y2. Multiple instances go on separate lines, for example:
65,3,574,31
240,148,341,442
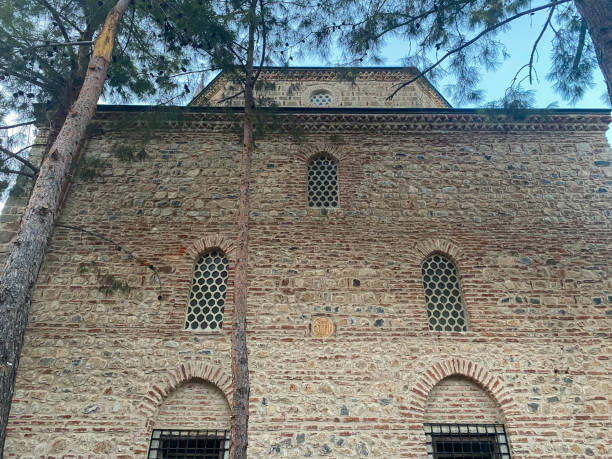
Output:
575,0,612,104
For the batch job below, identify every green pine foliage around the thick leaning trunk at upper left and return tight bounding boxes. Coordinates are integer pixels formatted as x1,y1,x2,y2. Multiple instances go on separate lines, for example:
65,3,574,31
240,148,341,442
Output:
0,0,198,198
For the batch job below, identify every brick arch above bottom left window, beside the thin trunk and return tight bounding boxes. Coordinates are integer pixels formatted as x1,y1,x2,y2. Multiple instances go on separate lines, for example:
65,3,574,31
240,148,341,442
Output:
138,362,234,424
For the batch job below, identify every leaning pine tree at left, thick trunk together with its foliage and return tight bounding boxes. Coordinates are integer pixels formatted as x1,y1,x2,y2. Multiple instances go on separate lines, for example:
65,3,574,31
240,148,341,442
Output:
0,0,227,451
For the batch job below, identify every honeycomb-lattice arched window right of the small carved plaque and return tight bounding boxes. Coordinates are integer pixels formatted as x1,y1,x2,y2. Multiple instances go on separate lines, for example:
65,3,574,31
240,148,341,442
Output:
422,255,468,332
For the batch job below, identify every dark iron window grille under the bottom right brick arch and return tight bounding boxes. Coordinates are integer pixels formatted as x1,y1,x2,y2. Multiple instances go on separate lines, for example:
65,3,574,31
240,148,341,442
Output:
425,424,510,459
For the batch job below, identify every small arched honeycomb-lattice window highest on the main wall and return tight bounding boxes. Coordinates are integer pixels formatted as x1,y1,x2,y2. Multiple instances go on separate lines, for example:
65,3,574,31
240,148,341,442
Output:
308,156,338,207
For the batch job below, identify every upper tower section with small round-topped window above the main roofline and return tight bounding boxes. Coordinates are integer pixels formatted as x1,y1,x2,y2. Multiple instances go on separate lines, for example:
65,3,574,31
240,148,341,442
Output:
191,67,450,108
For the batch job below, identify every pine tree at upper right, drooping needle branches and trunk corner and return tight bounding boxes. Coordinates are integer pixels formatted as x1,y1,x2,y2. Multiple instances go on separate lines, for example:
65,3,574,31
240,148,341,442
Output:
330,0,612,103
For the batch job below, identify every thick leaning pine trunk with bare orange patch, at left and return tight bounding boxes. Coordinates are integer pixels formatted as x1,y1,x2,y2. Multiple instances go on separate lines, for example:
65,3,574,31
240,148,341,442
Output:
0,0,130,452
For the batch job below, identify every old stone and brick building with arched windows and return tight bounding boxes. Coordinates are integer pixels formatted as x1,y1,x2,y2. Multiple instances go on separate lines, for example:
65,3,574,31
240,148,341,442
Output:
2,68,612,458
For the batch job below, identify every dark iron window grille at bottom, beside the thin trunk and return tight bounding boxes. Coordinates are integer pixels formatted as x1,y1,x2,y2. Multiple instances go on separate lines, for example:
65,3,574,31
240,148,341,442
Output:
147,429,229,459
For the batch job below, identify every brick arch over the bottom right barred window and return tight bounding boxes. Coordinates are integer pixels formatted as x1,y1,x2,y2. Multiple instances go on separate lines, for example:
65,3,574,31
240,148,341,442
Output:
409,358,519,426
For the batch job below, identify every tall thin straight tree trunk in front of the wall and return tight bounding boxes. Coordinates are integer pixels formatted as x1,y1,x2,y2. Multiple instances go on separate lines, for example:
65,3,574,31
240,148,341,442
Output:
230,1,256,459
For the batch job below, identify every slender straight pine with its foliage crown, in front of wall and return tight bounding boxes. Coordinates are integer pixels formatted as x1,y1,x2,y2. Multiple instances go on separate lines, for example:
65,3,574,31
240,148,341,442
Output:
148,0,338,459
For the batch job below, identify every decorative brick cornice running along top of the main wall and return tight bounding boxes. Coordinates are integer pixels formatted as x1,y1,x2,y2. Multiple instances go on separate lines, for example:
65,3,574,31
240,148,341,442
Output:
94,109,610,134
